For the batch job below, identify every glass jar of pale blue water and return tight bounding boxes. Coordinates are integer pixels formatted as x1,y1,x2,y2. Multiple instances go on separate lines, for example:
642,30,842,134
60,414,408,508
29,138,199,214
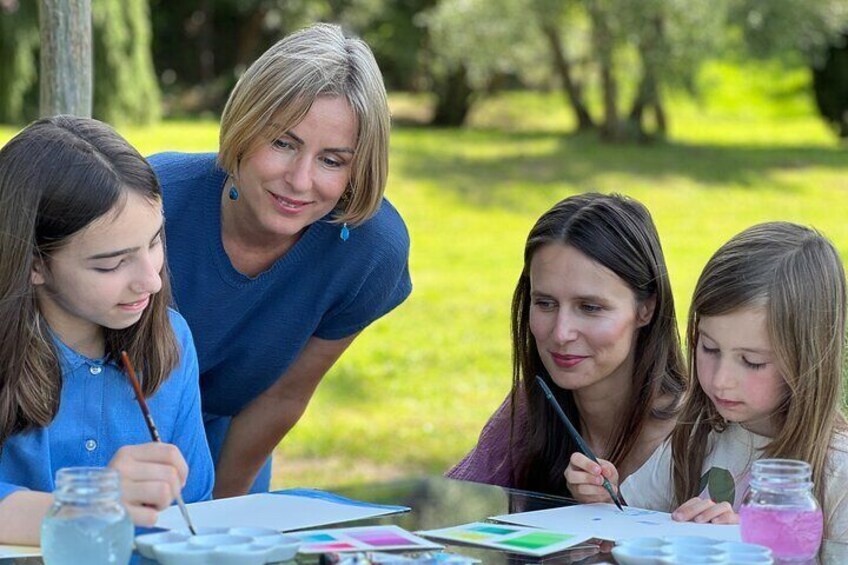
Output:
41,467,134,565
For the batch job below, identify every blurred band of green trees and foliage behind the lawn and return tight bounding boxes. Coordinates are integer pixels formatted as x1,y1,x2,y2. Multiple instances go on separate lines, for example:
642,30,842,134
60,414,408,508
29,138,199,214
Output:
6,0,848,140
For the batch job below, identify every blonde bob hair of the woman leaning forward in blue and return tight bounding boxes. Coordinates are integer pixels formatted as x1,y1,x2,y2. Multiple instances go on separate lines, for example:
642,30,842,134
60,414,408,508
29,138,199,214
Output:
218,24,390,225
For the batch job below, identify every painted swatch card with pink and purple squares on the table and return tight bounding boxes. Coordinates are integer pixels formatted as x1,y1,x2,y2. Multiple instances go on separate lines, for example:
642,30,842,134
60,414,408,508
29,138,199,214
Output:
286,526,444,553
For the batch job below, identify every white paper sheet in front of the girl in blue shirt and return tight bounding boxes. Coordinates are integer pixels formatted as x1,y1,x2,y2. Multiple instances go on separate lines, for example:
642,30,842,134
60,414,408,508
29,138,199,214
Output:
156,489,409,531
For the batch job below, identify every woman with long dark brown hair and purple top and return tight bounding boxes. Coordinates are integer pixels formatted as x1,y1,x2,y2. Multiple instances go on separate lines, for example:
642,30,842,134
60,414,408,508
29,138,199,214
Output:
448,194,685,495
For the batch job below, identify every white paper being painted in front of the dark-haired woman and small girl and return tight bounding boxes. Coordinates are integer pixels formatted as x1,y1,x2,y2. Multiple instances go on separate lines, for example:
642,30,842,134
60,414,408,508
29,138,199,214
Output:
491,504,741,541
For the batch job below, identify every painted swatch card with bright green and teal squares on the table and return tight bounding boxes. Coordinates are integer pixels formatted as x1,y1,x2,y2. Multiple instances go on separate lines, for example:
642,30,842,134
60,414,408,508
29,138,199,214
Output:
418,522,591,557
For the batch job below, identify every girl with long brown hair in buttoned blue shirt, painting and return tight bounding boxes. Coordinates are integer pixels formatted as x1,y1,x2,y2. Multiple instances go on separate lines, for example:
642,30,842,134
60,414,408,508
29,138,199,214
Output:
0,116,213,544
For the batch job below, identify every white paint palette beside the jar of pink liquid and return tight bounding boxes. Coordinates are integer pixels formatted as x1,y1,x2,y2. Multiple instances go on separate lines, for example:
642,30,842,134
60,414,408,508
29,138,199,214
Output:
612,536,774,565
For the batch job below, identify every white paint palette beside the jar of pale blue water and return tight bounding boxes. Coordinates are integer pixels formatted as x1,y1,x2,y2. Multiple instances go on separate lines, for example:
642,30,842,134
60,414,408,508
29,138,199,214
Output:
135,528,300,565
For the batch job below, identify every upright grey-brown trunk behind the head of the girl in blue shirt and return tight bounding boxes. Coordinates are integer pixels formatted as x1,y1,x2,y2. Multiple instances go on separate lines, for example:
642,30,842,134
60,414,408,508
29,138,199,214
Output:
39,0,92,117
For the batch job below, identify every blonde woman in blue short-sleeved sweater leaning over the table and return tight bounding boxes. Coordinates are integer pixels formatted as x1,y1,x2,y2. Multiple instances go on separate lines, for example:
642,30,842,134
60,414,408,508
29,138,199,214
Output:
150,24,411,497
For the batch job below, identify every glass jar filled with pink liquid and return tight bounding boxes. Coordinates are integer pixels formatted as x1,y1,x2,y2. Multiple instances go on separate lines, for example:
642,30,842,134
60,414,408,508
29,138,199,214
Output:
739,459,823,561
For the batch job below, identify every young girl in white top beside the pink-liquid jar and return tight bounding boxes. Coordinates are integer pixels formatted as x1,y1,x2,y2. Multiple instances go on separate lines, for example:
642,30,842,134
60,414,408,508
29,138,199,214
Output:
577,222,848,541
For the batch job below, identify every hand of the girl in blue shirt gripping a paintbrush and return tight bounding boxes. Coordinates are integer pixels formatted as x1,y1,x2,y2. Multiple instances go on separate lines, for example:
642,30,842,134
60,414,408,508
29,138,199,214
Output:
109,442,188,526
